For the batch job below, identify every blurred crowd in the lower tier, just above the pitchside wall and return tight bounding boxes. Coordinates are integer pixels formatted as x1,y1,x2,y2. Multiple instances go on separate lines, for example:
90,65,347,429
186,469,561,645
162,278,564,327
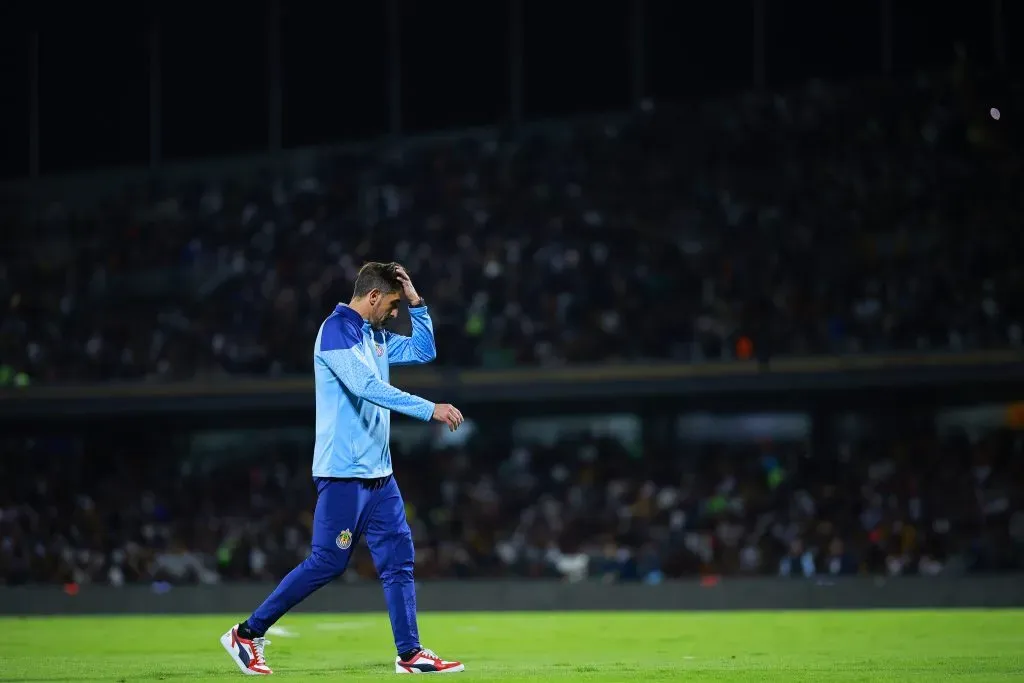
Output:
0,421,1024,585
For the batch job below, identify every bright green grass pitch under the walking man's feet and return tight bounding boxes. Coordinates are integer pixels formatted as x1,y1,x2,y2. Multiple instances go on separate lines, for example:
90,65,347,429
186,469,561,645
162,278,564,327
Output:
0,610,1024,683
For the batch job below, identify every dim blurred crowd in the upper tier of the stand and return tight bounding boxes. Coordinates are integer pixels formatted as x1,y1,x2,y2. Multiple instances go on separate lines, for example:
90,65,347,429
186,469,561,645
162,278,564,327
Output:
0,76,1024,384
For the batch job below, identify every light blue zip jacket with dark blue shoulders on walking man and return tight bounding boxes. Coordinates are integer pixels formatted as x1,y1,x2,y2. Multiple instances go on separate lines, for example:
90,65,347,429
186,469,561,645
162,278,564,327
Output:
312,304,437,479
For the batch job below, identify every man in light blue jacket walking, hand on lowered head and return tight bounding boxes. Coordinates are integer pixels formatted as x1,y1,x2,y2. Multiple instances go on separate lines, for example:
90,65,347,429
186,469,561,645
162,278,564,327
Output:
220,263,464,676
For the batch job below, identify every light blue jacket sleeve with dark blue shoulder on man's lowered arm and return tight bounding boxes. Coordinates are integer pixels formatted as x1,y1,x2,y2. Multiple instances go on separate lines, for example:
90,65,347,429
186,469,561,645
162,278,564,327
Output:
319,321,434,422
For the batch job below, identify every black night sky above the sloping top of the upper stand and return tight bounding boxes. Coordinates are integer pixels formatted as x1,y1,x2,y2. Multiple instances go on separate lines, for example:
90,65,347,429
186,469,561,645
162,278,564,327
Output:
0,0,1024,177
